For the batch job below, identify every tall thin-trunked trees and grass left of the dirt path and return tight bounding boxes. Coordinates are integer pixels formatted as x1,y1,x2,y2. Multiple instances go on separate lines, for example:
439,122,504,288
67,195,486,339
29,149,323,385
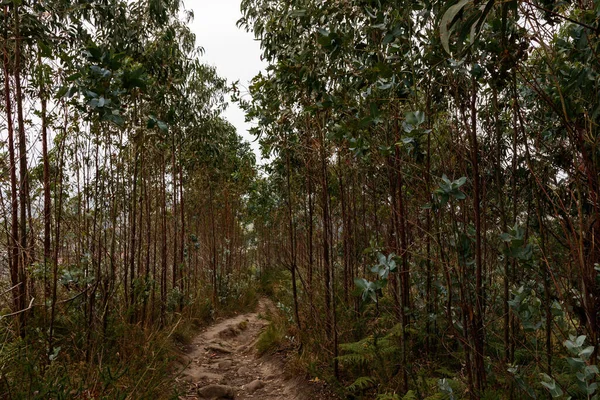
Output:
0,0,255,398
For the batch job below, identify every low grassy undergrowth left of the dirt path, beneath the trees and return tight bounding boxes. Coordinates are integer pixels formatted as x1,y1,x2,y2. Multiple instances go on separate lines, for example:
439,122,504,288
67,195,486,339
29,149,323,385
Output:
0,268,258,400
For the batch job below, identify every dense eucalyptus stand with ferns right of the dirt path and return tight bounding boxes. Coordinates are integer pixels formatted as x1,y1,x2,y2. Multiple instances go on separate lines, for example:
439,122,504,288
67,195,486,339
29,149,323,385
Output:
239,0,600,399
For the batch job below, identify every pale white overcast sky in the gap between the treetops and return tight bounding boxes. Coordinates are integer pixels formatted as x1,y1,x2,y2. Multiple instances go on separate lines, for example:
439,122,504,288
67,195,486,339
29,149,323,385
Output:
184,0,266,160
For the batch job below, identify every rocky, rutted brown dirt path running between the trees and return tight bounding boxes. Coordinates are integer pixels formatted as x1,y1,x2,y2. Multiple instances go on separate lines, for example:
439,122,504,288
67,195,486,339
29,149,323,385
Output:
176,299,335,400
